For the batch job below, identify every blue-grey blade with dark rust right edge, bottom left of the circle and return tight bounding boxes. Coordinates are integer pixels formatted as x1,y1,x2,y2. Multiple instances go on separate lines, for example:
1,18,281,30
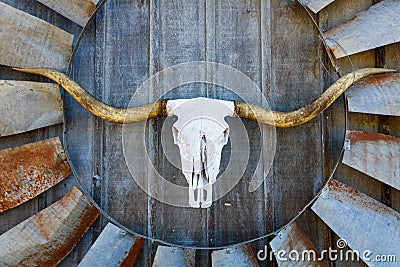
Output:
78,223,144,267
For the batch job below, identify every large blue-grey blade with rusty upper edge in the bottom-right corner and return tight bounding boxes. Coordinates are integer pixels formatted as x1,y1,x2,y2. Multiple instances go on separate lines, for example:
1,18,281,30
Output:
312,180,400,266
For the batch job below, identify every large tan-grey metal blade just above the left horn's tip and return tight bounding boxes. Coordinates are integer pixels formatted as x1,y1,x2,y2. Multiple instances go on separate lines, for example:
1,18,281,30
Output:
0,2,74,70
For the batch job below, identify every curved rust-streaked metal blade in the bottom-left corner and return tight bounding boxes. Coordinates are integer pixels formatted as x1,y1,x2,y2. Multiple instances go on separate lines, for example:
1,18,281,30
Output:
0,187,99,266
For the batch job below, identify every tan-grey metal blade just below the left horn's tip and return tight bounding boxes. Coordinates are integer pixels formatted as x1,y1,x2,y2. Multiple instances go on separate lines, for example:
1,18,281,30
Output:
0,80,63,136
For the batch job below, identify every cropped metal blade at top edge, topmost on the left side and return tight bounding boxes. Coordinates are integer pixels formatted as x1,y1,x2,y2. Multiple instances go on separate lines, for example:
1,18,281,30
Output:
37,0,99,27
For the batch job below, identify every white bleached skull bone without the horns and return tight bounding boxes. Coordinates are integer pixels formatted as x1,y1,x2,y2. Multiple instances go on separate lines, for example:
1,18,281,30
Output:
167,98,235,208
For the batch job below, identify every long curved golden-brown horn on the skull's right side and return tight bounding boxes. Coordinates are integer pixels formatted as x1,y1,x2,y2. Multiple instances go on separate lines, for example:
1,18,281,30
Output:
235,68,396,128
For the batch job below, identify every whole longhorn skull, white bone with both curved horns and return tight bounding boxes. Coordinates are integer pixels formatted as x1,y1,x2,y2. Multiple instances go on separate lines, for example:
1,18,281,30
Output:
12,68,395,208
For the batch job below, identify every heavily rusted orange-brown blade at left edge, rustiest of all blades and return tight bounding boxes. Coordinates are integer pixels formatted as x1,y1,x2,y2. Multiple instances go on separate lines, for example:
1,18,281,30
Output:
0,137,71,213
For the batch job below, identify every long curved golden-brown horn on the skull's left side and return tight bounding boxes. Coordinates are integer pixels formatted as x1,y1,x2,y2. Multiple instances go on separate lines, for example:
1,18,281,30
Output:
14,68,168,123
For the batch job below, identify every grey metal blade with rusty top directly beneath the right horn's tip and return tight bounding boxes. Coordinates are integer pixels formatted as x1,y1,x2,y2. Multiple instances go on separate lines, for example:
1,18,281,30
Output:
347,74,400,116
